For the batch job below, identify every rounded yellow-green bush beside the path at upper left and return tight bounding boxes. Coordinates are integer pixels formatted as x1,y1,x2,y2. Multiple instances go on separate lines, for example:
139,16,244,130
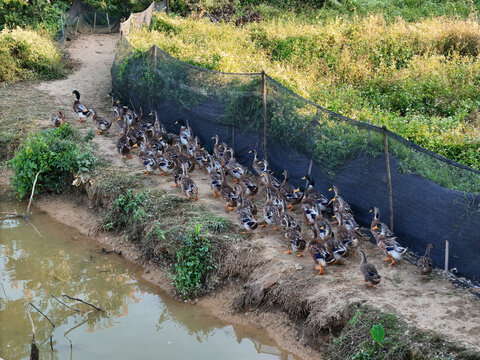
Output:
0,28,65,82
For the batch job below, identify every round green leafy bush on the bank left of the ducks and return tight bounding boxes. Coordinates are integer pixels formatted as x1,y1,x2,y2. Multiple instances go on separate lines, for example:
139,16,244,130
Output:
8,124,95,198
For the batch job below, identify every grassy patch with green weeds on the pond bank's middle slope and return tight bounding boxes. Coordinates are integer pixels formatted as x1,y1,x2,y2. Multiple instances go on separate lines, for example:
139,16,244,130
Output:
102,189,234,299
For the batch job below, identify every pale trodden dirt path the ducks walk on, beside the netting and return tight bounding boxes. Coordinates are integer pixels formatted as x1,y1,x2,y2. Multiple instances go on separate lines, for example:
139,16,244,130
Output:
21,31,480,350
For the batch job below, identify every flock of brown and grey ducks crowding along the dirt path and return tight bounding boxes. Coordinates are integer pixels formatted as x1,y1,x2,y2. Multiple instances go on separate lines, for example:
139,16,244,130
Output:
51,90,433,286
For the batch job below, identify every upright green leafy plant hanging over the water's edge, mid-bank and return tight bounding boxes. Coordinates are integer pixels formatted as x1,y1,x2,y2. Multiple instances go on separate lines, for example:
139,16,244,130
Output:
171,225,215,299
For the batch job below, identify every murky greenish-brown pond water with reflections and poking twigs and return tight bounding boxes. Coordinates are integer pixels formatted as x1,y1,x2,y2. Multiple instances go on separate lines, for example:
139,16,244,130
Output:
0,195,295,360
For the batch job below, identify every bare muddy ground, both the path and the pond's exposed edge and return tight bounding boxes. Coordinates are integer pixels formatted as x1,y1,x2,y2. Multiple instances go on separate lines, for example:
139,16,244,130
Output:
0,35,480,359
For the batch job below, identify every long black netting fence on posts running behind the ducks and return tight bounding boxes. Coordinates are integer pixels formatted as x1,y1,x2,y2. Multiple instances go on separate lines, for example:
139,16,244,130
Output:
112,4,480,280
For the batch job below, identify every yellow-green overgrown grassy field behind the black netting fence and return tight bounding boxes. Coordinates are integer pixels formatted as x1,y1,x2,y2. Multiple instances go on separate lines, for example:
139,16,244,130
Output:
129,1,480,173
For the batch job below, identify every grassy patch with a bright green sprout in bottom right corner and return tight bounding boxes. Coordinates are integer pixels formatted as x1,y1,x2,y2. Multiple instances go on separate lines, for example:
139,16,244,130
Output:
328,306,479,360
